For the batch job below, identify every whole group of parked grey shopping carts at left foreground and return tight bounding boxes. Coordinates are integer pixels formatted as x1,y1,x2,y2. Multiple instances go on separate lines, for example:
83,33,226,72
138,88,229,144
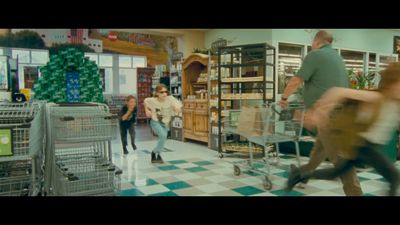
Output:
0,102,122,196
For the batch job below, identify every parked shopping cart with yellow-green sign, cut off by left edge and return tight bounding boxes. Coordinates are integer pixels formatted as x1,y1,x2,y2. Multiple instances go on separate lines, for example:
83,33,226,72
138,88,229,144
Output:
0,101,45,196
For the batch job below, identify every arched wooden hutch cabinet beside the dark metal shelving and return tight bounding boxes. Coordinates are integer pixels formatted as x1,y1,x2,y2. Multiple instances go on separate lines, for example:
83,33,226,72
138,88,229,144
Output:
182,53,209,143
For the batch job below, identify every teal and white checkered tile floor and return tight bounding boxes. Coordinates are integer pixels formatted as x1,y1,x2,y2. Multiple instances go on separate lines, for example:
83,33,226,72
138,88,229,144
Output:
112,134,400,196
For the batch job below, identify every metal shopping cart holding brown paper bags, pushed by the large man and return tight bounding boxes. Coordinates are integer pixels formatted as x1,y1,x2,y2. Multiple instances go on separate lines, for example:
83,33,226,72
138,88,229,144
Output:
223,103,305,190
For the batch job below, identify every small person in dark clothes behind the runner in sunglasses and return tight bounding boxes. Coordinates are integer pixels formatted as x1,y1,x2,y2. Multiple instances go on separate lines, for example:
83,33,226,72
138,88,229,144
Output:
119,95,137,155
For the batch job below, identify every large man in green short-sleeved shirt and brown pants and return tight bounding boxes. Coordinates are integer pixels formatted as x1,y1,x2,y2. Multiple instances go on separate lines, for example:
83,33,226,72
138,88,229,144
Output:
279,30,362,196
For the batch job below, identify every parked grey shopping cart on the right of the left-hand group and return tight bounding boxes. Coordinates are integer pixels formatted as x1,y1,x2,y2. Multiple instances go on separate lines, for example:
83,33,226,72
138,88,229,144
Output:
45,103,122,196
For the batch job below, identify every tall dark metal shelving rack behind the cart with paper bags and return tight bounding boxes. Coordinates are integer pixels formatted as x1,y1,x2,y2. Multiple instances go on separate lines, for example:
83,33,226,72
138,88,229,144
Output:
217,43,276,158
